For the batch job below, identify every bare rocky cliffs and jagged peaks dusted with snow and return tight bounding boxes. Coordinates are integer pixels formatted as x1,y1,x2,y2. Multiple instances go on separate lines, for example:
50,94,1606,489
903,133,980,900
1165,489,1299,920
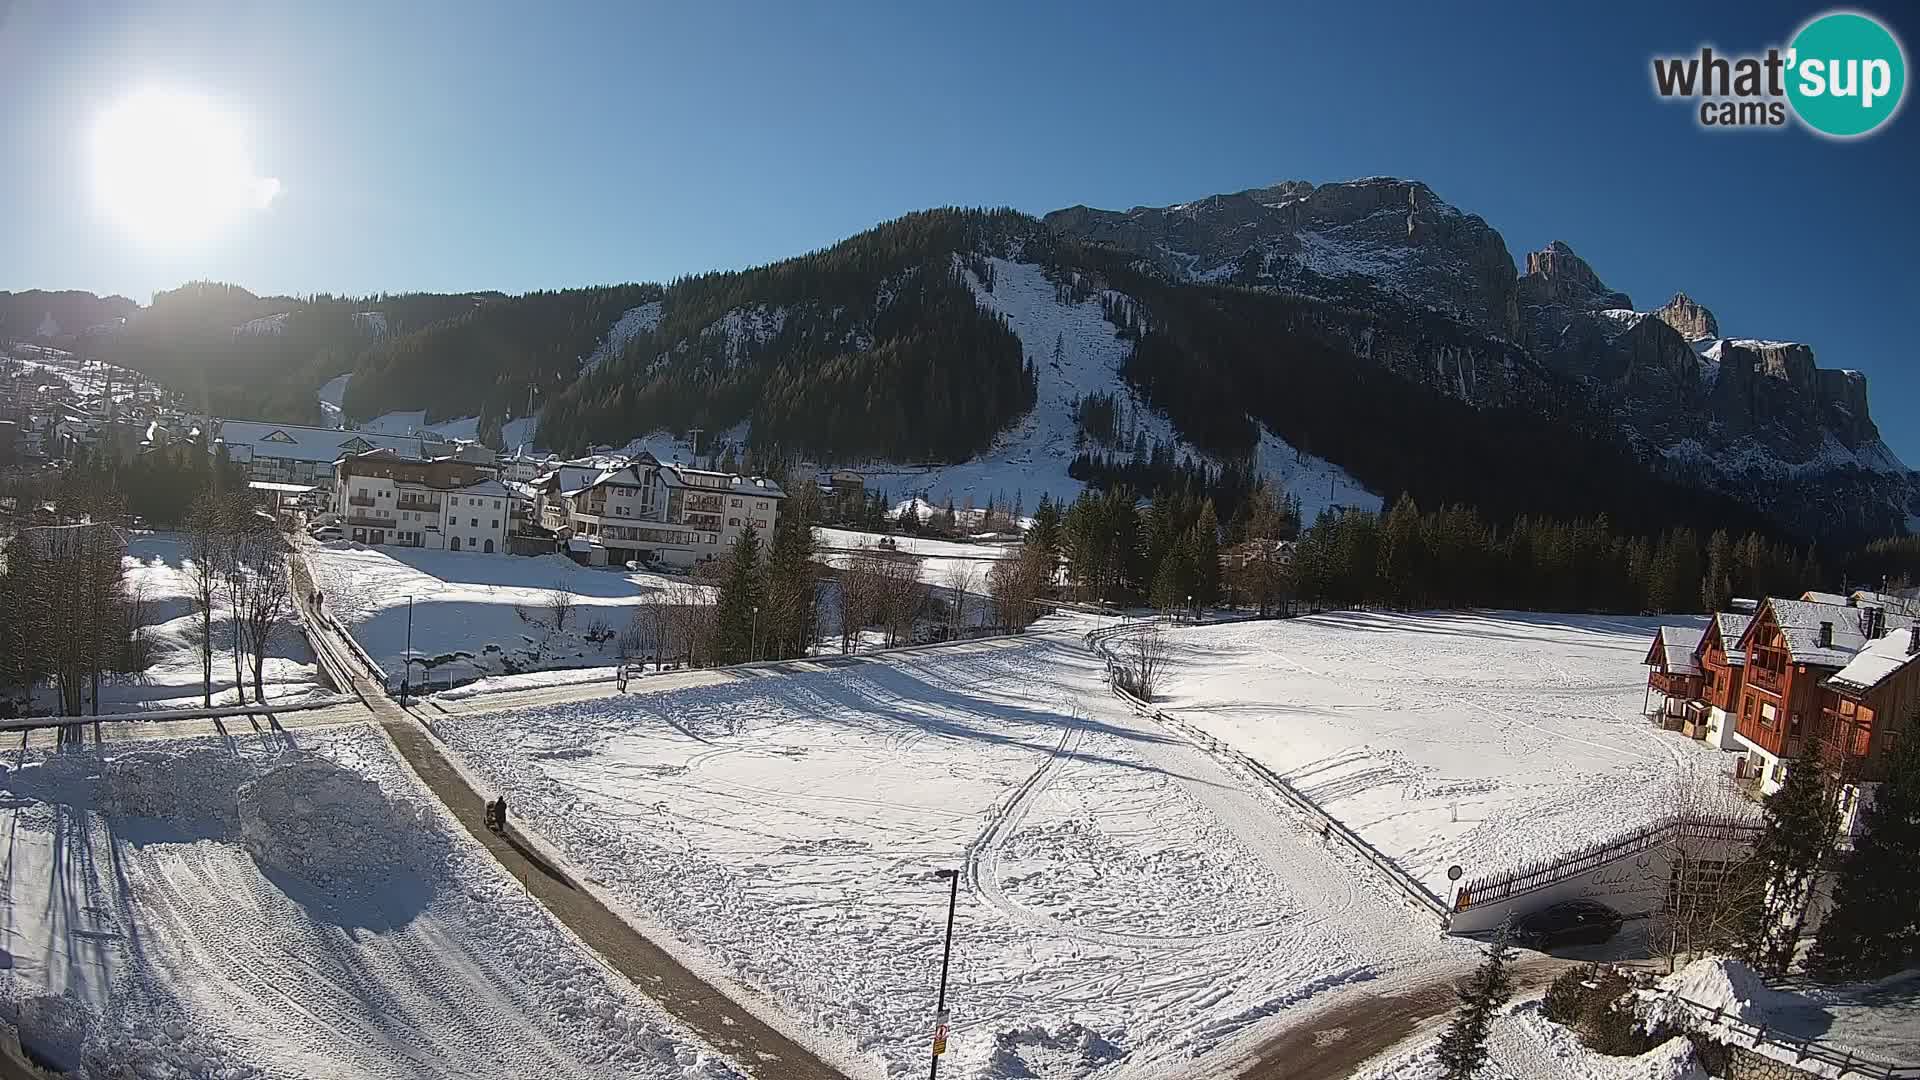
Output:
1046,177,1920,534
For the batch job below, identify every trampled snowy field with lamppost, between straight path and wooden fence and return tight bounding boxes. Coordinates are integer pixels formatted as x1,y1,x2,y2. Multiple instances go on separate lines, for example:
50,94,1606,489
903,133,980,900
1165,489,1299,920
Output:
434,621,1465,1078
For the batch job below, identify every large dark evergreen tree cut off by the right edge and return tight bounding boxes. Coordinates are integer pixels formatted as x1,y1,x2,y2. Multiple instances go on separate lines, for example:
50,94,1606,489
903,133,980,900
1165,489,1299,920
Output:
1807,717,1920,982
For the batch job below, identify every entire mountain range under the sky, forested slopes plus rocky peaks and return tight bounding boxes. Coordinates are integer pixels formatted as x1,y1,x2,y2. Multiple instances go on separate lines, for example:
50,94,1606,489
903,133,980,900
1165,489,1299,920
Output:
7,177,1920,540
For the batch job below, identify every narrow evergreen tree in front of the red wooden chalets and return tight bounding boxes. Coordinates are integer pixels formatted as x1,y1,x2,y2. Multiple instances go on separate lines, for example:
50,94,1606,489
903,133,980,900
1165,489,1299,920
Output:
1741,738,1836,976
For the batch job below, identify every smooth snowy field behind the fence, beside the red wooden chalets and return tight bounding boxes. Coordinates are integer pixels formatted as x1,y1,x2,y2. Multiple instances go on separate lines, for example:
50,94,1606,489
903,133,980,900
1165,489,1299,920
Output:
1158,613,1743,896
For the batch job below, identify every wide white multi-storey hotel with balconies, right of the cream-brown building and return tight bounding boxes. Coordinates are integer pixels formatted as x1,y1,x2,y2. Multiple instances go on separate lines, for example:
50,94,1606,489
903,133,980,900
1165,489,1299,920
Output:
532,454,787,567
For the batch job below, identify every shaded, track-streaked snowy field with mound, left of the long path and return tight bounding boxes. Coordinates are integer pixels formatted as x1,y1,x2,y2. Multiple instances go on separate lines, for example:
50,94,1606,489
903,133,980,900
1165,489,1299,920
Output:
0,726,735,1080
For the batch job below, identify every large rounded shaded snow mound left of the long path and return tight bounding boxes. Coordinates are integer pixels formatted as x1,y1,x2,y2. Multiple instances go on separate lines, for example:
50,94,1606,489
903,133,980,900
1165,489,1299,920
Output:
236,757,428,886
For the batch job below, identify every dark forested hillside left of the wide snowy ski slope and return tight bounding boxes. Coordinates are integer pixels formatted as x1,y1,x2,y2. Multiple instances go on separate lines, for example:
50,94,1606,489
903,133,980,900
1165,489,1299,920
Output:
540,209,1039,461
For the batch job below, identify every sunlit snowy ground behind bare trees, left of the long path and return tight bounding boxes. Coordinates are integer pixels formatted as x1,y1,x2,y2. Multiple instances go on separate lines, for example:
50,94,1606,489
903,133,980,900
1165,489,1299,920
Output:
18,532,326,713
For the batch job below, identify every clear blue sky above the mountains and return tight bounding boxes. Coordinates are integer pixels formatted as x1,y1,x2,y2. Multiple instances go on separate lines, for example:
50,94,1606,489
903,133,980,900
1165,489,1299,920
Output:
0,0,1920,463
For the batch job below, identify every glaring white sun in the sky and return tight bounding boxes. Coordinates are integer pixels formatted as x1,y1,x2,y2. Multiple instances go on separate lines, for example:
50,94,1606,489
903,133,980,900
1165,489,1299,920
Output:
94,90,280,246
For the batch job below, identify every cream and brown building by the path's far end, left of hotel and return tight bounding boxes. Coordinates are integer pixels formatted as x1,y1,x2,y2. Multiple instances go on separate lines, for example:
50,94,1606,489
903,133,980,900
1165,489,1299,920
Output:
332,450,513,555
